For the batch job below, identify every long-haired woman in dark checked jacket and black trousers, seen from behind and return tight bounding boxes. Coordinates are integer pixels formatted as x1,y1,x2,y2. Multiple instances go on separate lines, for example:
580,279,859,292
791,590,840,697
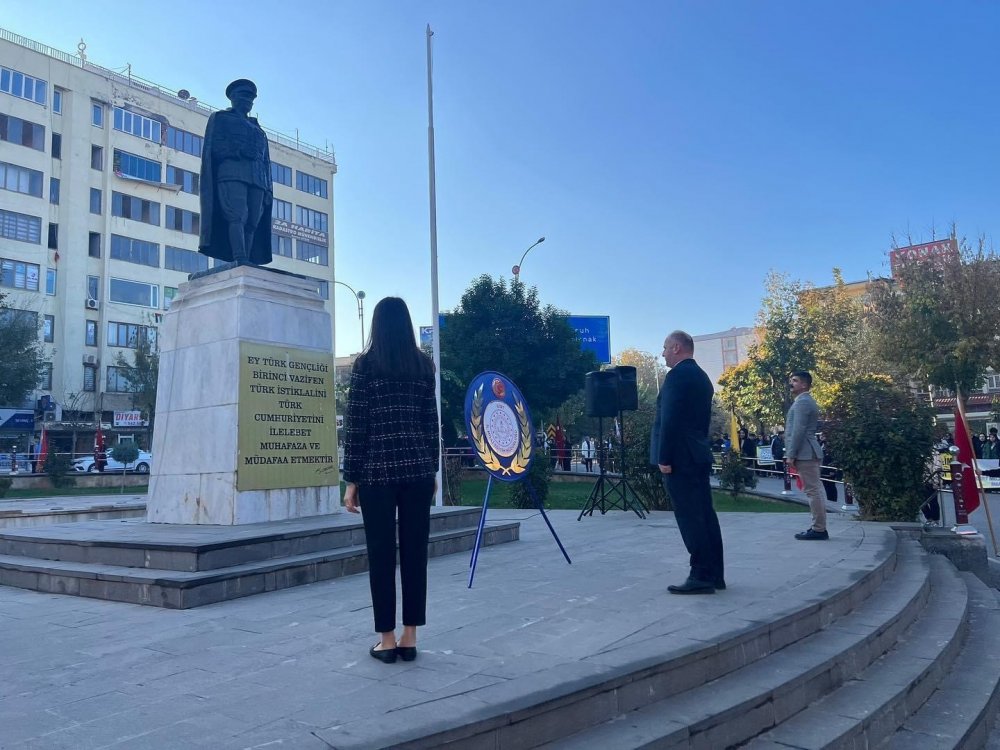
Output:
344,297,440,664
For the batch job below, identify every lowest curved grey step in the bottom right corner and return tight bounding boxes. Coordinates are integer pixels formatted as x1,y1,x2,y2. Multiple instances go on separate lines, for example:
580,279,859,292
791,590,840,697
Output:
880,573,1000,750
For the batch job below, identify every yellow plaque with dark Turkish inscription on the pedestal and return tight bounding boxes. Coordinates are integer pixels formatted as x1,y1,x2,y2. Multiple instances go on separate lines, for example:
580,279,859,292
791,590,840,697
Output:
236,342,340,492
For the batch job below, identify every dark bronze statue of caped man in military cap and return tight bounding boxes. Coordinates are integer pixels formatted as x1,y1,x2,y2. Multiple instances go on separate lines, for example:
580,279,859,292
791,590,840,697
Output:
198,78,274,266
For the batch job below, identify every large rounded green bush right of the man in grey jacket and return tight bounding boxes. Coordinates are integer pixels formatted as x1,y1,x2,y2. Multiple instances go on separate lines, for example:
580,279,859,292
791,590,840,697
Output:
825,376,934,521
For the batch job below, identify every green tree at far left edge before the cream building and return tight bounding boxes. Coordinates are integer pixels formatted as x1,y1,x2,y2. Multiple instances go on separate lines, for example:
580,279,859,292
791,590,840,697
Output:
0,292,45,406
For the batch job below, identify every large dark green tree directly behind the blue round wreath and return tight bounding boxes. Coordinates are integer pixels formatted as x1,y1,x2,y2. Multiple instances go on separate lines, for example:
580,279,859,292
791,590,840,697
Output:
441,275,598,443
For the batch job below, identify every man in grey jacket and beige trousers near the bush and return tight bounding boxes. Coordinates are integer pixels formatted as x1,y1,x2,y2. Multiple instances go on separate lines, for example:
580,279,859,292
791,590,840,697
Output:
785,370,830,541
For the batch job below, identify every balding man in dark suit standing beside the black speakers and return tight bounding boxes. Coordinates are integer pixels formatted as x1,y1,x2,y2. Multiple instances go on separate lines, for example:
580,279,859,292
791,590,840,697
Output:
649,331,726,594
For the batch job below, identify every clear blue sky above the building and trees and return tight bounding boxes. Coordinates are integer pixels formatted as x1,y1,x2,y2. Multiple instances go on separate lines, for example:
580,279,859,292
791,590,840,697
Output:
9,0,1000,354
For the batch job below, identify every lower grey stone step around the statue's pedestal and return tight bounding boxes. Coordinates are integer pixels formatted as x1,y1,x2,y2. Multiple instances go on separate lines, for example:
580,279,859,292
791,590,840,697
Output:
0,514,520,609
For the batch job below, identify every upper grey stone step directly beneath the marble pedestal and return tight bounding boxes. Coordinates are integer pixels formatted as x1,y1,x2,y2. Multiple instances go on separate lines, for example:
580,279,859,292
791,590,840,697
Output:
0,508,488,571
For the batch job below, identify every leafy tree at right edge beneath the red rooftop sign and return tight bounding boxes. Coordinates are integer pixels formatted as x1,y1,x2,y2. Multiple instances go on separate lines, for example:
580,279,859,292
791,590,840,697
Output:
871,238,1000,406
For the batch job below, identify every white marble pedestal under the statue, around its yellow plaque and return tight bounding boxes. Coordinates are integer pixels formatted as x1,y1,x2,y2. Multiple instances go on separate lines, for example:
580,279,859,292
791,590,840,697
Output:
146,266,340,525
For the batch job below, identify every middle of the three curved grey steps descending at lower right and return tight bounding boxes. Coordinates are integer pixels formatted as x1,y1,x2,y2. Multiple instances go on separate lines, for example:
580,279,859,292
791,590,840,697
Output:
745,555,970,750
